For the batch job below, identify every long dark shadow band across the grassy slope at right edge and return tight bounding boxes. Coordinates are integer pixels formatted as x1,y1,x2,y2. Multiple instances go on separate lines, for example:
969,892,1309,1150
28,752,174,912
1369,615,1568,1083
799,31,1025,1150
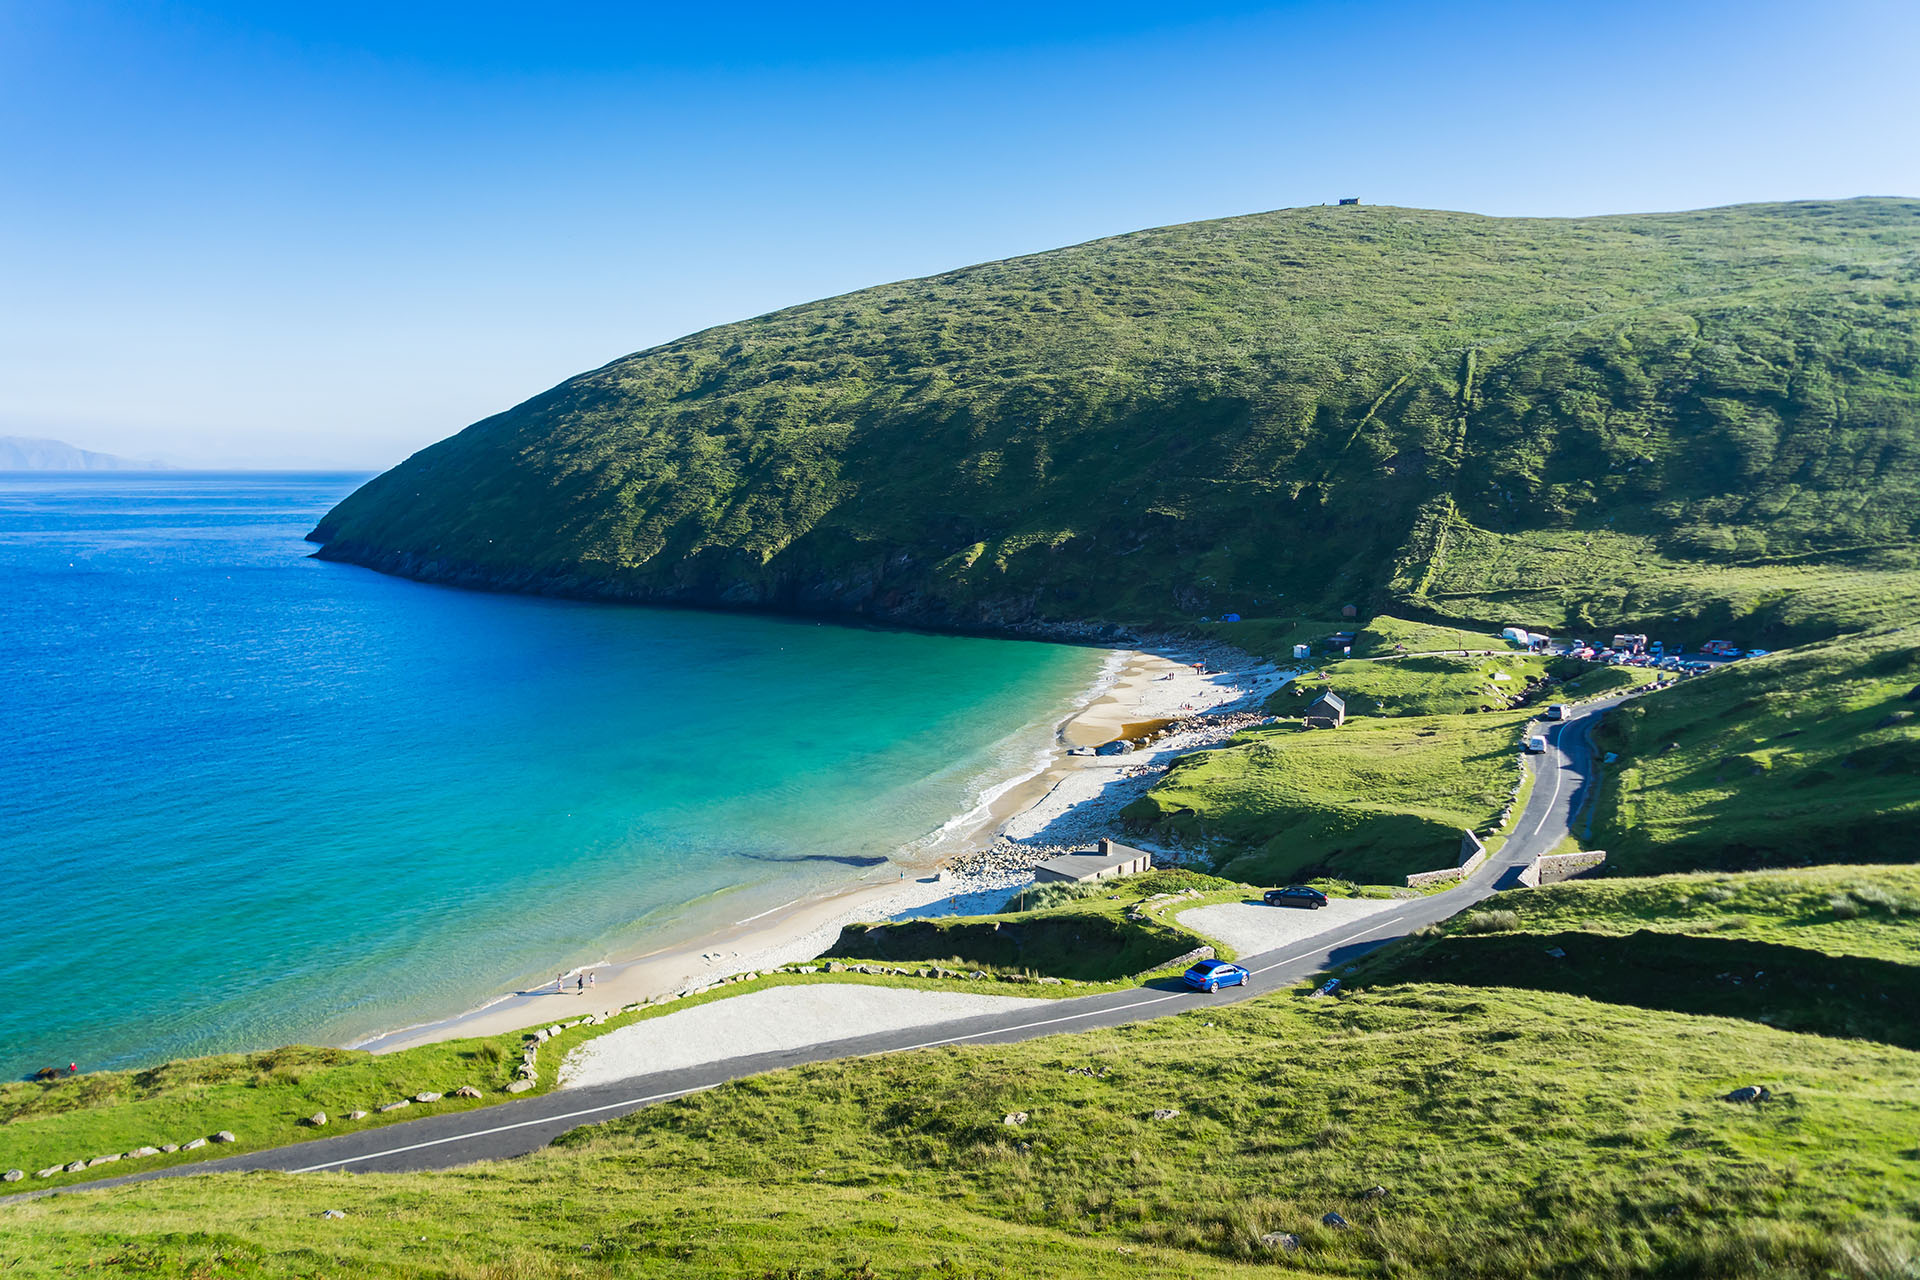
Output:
1361,929,1920,1050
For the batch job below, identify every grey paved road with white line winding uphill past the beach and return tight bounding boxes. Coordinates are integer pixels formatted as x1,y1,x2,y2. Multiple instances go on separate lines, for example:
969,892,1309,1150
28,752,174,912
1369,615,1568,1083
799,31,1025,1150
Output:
15,697,1624,1199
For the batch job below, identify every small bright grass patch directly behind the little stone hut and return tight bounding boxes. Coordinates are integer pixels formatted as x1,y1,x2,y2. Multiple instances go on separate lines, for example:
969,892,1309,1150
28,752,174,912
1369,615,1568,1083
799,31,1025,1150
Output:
1267,652,1548,716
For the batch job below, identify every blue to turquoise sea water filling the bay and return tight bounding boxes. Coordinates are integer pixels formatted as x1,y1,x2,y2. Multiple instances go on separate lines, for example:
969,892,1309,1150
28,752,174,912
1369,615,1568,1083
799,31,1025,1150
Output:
0,476,1100,1077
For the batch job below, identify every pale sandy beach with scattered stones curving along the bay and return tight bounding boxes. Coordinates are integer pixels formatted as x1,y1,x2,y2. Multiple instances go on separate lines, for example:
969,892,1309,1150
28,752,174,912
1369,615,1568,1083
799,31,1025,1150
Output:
357,643,1290,1054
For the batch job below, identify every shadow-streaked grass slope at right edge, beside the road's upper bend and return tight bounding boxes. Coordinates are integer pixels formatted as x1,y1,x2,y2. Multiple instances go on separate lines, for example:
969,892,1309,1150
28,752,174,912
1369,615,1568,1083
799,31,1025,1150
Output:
1592,626,1920,873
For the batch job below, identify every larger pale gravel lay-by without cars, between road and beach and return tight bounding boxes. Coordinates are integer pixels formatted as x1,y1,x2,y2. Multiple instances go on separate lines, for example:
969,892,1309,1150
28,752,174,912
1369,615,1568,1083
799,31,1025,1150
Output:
561,983,1048,1088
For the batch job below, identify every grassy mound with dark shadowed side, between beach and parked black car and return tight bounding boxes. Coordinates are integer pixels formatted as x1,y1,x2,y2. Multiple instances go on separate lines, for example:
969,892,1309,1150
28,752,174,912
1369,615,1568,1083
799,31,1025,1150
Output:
826,871,1246,983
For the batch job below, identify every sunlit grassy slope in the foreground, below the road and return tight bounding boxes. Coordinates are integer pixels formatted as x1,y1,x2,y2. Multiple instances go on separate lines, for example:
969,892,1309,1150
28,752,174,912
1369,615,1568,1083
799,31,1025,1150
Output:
0,984,1920,1280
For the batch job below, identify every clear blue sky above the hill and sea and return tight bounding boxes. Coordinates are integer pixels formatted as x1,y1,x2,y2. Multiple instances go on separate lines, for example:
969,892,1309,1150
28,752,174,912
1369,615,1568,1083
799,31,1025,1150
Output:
0,0,1920,468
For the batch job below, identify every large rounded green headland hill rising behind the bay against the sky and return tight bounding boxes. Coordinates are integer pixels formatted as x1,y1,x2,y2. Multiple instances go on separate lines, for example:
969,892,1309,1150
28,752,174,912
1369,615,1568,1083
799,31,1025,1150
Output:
315,200,1920,647
